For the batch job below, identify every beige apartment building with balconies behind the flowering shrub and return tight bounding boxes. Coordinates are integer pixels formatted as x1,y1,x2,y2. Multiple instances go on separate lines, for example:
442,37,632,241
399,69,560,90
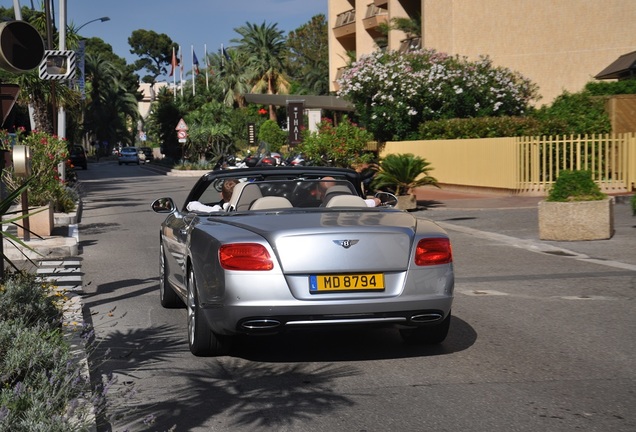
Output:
328,0,636,105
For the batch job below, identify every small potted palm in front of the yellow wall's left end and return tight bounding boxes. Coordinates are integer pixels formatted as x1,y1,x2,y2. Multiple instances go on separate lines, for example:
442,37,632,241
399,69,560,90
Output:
373,153,439,210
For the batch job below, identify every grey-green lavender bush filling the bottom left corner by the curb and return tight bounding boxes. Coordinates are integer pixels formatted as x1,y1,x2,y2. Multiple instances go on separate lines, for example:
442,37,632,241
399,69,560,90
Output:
0,273,100,432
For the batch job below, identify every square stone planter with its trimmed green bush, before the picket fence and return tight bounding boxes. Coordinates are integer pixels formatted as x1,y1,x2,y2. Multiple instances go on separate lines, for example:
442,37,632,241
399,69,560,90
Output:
539,170,614,241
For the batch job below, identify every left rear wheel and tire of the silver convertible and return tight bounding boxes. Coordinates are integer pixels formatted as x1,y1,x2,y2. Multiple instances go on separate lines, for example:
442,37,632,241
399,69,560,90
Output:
186,268,230,357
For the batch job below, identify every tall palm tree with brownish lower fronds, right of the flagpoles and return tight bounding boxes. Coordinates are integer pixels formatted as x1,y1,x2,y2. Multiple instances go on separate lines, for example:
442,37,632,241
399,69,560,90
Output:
232,22,289,121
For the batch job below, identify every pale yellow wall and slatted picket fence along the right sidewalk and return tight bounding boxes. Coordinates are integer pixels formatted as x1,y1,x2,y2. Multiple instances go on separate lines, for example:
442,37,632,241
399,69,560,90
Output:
380,133,636,195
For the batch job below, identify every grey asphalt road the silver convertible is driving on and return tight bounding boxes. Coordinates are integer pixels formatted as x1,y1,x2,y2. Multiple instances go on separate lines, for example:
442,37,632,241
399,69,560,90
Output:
79,163,636,432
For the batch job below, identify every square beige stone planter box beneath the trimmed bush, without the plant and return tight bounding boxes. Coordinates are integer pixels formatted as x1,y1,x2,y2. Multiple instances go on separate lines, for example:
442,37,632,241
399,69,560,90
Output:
539,197,614,241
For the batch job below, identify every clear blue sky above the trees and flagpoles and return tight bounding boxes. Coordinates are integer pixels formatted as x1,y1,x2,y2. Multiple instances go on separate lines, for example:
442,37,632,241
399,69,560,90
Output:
0,0,327,78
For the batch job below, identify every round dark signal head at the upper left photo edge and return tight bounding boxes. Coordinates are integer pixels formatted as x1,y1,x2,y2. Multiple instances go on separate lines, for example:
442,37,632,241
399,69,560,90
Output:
0,21,44,73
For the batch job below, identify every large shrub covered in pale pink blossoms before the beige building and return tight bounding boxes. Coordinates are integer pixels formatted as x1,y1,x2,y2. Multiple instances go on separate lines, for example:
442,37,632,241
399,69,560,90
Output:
338,50,538,141
